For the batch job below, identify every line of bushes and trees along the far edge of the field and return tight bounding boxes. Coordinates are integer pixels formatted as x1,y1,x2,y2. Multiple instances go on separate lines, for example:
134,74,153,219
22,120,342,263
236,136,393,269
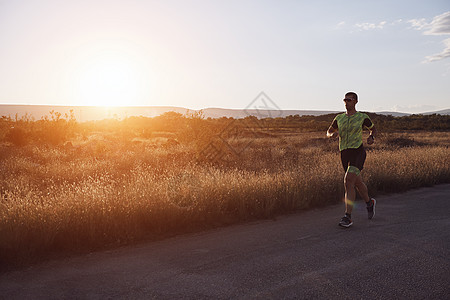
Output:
0,111,450,146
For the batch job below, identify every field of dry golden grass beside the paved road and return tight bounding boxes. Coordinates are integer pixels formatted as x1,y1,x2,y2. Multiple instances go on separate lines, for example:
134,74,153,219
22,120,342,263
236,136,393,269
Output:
0,113,450,266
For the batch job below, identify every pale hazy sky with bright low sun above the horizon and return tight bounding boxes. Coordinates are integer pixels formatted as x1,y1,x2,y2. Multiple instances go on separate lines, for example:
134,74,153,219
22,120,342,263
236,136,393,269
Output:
0,0,450,113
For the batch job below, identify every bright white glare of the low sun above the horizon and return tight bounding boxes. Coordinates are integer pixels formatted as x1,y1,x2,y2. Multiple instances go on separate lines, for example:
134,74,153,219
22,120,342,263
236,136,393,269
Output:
66,40,154,106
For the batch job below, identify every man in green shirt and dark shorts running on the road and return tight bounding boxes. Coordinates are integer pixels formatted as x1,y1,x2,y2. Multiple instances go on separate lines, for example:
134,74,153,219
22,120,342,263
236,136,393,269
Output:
327,92,377,228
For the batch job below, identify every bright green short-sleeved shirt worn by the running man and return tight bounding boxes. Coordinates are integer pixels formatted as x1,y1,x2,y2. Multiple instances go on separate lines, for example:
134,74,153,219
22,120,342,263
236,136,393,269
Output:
331,111,374,151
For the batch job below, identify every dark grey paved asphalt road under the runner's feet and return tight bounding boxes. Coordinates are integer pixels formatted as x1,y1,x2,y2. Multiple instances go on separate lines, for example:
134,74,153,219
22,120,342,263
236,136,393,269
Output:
0,185,450,299
